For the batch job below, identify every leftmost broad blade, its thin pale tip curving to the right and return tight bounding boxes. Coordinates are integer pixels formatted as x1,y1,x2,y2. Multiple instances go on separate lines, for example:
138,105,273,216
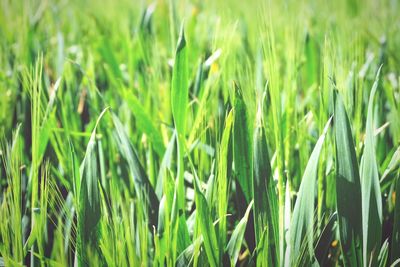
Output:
77,108,108,266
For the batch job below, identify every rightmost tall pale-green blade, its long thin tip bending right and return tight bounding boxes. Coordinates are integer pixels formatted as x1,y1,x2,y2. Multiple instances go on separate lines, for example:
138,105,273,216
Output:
360,68,382,266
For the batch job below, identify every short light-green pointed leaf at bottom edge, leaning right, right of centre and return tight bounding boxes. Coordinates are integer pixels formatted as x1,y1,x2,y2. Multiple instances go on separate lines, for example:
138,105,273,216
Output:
226,201,253,266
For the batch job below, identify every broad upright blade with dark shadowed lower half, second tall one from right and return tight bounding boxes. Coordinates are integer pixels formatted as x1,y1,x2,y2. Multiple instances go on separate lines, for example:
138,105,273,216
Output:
334,91,362,266
